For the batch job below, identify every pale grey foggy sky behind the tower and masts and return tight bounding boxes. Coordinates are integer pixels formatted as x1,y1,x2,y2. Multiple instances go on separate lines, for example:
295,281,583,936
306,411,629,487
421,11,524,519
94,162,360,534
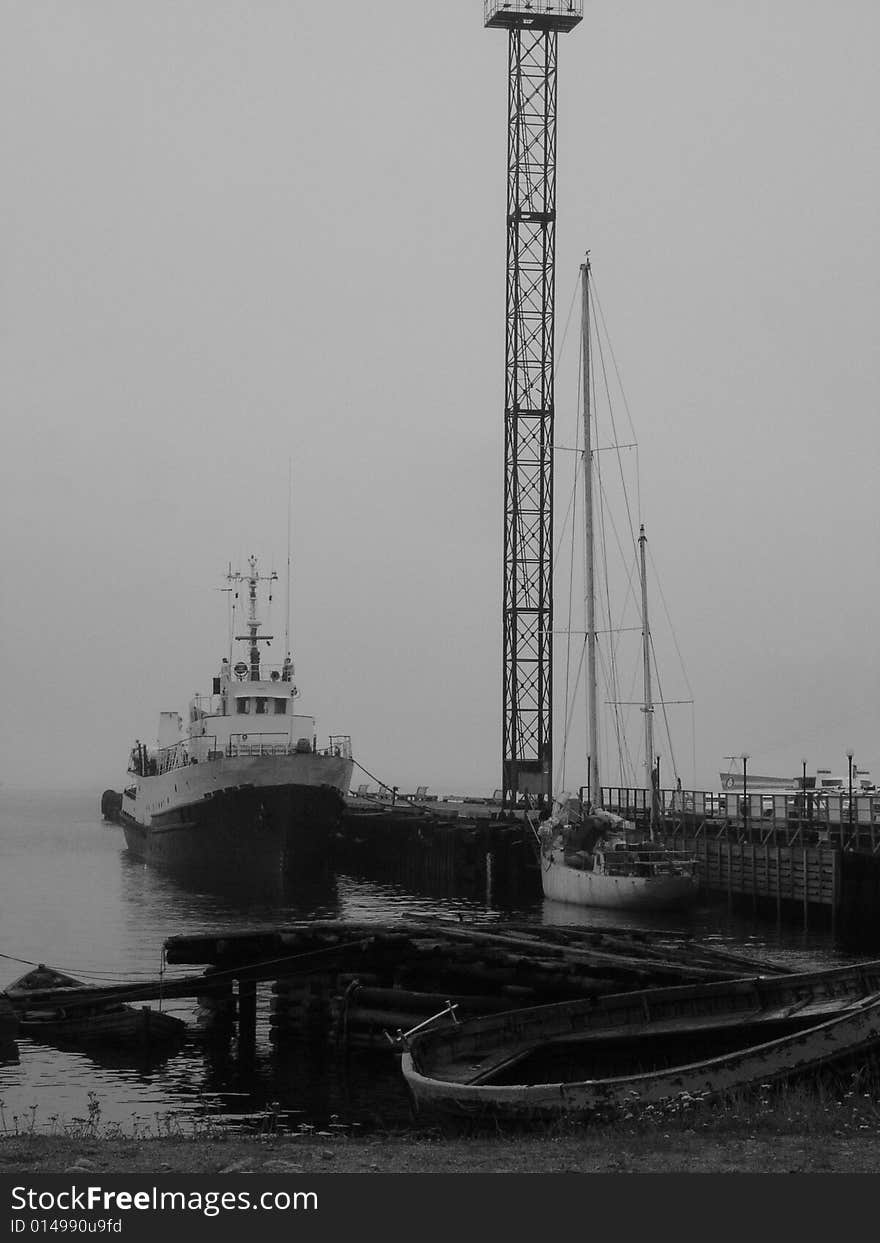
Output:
0,0,880,798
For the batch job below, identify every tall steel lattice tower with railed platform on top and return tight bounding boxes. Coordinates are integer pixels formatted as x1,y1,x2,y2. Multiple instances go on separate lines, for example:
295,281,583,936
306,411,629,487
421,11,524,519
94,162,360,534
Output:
485,0,583,803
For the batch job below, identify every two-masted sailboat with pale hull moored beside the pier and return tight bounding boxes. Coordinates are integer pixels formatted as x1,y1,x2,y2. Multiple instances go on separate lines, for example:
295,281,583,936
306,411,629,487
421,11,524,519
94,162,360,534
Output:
536,261,699,910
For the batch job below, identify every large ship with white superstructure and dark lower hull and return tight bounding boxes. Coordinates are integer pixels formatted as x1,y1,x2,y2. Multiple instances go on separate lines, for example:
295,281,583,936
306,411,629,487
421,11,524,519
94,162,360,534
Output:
117,557,353,874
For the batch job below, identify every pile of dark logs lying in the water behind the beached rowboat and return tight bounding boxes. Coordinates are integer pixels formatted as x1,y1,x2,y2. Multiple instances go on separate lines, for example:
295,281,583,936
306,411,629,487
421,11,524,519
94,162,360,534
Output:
3,916,784,1052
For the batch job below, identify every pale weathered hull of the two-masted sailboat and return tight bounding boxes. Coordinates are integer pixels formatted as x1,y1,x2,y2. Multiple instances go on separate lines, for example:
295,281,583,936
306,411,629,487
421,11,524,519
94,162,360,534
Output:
541,853,700,911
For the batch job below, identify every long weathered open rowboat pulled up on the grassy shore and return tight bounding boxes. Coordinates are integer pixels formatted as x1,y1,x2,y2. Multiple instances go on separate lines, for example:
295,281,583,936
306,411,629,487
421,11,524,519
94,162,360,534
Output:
401,961,880,1120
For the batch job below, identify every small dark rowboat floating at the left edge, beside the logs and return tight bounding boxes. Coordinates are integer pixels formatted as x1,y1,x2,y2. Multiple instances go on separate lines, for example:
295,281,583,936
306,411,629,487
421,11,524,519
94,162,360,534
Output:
5,963,186,1048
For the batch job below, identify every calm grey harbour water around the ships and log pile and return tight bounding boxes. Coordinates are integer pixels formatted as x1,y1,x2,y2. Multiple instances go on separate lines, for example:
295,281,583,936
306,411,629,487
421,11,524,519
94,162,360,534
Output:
0,788,846,1134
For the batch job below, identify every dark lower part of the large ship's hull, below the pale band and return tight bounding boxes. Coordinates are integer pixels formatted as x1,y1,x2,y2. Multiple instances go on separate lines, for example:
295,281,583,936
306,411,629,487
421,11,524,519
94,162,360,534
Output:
121,784,344,874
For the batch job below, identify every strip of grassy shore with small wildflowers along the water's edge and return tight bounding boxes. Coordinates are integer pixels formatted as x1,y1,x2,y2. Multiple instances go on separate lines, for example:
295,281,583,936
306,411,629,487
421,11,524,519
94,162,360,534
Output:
6,1116,880,1177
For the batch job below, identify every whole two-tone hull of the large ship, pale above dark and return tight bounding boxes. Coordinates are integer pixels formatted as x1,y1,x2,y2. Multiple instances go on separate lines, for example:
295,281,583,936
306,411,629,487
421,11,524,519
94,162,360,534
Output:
119,755,352,875
